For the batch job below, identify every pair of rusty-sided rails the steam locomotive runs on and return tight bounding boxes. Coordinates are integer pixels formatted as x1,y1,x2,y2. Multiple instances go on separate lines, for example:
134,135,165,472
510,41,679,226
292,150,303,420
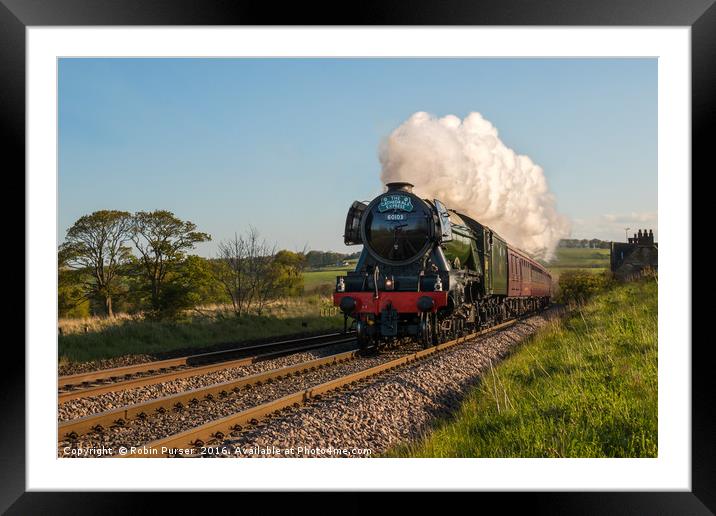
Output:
58,320,517,457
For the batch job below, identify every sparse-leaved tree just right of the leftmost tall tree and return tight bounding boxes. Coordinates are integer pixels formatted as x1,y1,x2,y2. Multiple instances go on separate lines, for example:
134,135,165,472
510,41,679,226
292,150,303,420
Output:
131,210,211,313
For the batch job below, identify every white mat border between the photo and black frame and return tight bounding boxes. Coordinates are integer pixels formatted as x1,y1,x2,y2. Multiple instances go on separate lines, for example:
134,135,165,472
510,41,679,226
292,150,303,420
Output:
26,27,691,491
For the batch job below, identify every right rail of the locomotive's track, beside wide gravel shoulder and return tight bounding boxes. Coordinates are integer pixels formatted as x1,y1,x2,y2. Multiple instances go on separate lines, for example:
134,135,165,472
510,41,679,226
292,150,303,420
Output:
119,319,518,457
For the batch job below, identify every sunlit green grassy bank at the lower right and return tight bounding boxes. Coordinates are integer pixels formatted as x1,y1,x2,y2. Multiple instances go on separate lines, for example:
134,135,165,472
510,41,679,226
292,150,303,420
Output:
388,279,658,457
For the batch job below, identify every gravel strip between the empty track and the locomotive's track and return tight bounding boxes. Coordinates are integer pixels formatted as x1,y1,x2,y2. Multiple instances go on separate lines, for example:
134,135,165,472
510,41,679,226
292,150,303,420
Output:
57,343,355,421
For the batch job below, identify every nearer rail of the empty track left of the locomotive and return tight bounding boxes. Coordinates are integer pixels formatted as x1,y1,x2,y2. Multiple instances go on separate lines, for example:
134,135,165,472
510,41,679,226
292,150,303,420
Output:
57,337,355,404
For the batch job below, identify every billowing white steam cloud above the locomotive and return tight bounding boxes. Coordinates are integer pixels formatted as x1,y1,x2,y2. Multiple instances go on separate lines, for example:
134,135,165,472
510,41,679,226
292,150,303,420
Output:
379,112,570,259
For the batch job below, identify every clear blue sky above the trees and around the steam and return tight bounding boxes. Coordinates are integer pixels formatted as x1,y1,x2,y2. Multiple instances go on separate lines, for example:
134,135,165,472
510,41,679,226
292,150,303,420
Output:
59,59,657,256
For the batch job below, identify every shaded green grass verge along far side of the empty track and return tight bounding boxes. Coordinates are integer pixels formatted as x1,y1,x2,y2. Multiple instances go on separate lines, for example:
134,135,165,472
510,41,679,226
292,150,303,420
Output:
58,305,343,363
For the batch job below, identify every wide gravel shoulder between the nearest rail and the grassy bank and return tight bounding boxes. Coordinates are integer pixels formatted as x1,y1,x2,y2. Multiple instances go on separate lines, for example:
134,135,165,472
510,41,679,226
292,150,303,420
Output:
218,307,561,457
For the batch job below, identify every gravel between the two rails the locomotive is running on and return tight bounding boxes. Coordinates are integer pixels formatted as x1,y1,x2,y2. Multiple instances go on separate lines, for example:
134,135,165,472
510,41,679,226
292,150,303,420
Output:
58,346,418,457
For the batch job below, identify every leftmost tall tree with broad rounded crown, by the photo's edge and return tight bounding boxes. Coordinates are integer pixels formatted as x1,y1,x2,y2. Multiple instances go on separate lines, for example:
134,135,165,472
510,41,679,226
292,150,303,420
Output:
58,210,132,317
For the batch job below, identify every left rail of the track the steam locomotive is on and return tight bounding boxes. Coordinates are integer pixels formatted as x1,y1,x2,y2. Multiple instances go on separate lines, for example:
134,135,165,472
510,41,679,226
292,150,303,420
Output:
57,350,358,441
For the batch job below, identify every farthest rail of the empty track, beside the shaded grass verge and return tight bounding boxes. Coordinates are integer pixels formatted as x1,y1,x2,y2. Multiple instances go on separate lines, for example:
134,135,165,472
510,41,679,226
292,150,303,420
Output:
57,333,354,389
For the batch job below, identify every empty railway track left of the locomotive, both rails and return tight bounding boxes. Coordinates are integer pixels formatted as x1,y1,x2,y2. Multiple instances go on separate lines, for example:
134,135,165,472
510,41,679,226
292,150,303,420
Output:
57,333,355,404
